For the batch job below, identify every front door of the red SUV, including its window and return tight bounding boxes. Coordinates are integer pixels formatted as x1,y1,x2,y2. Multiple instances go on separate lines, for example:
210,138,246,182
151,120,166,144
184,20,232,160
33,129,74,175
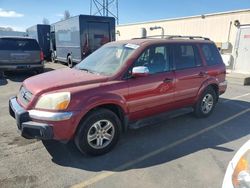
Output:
128,46,174,120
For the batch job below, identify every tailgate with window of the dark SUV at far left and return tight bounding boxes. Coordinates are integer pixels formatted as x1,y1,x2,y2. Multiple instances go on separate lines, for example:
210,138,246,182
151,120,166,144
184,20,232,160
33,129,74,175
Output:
0,38,40,65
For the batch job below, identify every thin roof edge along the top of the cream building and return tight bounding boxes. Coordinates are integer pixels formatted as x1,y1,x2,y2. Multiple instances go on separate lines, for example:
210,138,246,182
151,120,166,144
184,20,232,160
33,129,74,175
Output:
118,9,250,27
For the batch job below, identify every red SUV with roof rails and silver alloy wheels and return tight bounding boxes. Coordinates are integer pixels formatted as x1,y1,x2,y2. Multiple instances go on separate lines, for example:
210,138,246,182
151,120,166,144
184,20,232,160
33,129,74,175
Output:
9,36,227,155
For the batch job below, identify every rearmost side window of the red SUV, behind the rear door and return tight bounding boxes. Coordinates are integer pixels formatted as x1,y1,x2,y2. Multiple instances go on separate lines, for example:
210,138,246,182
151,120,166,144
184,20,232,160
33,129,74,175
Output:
201,44,222,66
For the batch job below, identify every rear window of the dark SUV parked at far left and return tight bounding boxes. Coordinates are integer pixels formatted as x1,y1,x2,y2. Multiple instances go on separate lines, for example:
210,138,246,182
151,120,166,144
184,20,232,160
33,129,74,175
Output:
0,38,40,51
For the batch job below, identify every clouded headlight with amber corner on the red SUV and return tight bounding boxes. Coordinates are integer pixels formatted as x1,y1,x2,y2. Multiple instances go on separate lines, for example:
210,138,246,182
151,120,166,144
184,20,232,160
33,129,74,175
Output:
35,92,70,110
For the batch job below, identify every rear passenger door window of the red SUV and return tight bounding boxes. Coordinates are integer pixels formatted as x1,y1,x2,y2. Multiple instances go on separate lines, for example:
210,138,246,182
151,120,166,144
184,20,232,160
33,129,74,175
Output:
174,44,201,70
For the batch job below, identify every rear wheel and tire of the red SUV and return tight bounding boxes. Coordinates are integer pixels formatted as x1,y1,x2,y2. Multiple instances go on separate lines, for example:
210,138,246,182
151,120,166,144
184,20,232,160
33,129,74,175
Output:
194,87,217,118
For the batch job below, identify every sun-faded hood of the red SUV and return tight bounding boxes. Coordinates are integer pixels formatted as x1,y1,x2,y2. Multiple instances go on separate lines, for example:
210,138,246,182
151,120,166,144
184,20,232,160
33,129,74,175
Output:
23,68,108,95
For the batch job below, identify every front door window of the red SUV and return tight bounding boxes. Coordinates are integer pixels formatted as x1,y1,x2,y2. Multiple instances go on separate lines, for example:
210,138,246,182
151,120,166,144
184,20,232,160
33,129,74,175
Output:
134,46,170,74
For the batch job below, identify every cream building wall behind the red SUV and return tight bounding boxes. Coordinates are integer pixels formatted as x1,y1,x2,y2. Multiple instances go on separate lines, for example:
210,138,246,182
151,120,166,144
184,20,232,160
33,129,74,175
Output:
117,9,250,73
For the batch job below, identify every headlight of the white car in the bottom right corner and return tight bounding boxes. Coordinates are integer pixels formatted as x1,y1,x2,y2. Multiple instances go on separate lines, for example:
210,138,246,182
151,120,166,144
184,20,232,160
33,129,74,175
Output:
232,150,250,188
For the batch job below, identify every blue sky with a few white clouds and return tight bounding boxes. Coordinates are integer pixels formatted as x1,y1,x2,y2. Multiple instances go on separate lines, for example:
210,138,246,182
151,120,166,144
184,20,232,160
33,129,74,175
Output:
0,0,250,31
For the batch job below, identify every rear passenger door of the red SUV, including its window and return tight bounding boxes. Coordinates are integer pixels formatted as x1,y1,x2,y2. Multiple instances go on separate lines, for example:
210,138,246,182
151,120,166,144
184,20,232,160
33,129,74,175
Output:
173,43,207,102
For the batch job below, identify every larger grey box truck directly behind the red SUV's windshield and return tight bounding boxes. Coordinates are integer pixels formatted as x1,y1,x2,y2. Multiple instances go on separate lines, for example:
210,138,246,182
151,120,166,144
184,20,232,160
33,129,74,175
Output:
51,15,115,67
